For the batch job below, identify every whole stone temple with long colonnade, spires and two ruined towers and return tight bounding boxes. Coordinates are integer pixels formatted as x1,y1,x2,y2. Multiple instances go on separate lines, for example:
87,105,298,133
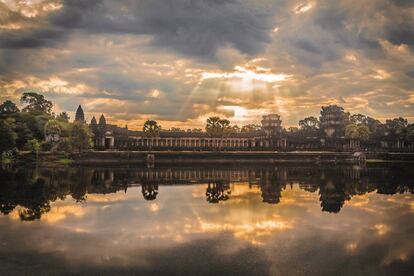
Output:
75,106,410,151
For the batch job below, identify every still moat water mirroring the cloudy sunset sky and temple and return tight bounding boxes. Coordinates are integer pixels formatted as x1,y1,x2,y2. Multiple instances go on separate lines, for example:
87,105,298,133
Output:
0,165,414,275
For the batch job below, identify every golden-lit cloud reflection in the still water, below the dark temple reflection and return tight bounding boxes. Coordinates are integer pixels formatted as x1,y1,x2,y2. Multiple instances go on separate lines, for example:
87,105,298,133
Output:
0,183,414,271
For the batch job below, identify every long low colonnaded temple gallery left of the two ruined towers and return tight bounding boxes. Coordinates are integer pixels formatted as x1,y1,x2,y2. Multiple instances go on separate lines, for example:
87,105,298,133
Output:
90,115,286,150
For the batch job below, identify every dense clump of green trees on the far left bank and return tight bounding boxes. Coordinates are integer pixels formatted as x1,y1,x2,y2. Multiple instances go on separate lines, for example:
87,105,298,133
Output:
0,92,92,156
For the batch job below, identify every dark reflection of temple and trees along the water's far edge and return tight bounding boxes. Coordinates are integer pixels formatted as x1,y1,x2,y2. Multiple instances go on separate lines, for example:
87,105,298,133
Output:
0,166,414,220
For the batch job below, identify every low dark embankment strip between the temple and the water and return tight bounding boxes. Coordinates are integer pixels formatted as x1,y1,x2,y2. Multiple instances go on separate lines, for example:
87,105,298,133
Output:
8,151,414,167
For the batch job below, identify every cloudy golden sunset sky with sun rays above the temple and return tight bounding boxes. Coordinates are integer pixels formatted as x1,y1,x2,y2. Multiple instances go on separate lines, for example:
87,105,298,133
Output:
0,0,414,129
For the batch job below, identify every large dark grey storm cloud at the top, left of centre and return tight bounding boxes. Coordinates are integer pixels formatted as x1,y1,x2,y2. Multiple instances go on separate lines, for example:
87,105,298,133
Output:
49,0,275,59
